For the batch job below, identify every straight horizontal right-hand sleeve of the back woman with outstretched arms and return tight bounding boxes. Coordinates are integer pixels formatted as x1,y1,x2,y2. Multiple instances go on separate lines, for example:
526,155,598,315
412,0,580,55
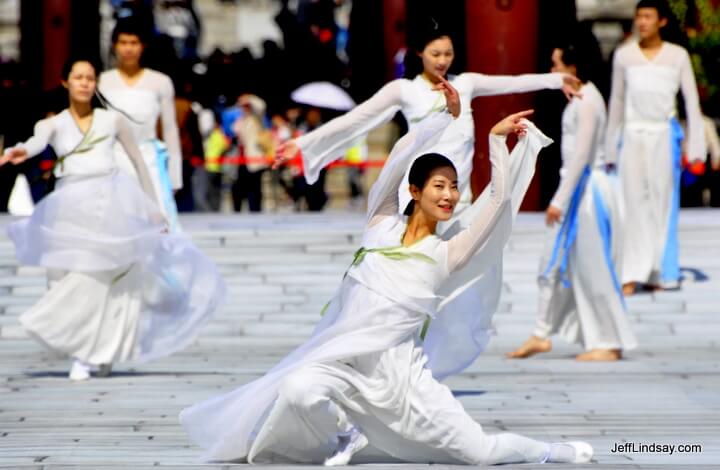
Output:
470,73,563,98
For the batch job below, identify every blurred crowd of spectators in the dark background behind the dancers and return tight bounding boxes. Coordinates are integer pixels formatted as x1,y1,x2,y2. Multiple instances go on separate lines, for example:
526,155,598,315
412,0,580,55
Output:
0,0,720,212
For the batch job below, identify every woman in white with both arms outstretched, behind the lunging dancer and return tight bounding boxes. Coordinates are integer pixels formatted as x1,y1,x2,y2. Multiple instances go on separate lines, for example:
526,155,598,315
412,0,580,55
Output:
277,23,578,214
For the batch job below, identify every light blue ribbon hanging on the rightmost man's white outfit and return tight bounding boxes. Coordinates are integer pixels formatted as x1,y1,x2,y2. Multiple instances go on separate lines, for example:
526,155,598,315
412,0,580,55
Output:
660,118,684,282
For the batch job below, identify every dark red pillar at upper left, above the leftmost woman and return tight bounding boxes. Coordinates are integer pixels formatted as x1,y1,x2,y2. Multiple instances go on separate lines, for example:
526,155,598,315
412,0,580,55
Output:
42,0,71,90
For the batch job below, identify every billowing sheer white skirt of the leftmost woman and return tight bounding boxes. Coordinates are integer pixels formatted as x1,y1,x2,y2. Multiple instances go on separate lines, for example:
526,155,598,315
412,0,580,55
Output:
8,172,225,364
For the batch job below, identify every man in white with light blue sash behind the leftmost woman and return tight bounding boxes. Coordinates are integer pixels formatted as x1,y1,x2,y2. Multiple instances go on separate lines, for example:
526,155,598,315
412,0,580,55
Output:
98,19,183,231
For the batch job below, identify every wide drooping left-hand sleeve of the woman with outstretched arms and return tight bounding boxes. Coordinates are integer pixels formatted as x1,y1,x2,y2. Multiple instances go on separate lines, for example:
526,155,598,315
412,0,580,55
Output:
296,80,402,184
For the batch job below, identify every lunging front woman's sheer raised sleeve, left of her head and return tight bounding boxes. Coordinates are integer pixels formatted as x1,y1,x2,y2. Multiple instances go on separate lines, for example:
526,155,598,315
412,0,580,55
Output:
367,112,453,227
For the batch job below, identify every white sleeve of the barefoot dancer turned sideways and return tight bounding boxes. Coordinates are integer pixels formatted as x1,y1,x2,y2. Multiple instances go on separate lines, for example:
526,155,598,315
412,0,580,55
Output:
550,100,602,213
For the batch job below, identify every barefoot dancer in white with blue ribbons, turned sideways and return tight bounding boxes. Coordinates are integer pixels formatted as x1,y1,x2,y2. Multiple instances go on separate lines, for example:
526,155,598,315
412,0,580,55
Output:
508,45,637,361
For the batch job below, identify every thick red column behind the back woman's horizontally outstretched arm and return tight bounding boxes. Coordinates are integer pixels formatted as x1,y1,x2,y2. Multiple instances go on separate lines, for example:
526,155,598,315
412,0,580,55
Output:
465,0,541,210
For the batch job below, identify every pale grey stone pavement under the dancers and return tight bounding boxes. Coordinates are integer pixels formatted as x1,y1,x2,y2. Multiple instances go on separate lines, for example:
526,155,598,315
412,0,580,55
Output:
0,211,720,469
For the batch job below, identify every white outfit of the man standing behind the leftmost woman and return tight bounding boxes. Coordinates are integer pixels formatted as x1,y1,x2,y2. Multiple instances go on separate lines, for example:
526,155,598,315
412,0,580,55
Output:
98,69,183,230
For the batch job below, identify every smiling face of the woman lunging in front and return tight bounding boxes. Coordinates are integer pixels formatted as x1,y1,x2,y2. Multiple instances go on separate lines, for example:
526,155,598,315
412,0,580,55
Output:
410,166,460,222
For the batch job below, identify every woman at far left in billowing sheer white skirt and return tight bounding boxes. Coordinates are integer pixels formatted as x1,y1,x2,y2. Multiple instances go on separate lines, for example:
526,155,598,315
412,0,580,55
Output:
0,60,224,380
